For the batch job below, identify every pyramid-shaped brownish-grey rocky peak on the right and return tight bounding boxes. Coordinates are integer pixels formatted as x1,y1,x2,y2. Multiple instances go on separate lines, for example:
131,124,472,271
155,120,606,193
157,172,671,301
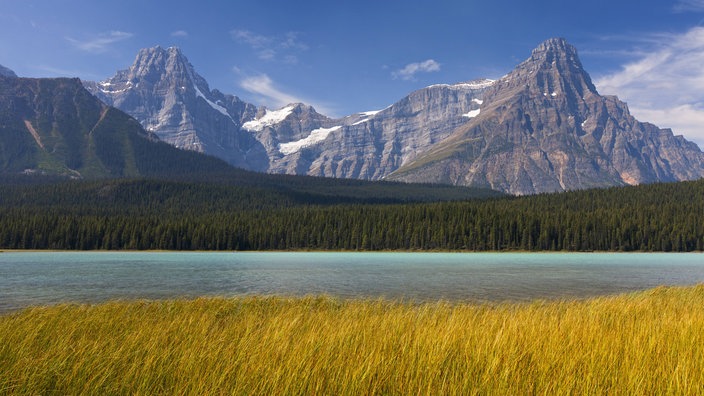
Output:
389,39,704,194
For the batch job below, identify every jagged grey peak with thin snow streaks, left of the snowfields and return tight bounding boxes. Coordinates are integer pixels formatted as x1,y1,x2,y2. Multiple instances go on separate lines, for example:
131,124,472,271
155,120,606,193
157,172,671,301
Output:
85,46,269,171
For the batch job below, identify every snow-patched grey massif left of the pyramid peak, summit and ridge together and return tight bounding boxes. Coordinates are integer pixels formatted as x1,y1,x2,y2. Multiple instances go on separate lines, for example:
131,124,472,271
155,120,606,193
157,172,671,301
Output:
84,46,496,180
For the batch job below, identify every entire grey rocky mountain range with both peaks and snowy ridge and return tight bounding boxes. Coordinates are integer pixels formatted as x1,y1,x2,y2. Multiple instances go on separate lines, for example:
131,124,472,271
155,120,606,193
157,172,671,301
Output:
85,39,704,194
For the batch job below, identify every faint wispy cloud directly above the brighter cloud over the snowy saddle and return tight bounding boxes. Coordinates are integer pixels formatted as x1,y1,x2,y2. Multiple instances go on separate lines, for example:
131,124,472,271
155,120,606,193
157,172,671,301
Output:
230,29,308,64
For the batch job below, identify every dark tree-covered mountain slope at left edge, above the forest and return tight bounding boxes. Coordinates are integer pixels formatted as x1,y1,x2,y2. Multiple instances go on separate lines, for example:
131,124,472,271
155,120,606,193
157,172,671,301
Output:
0,77,238,178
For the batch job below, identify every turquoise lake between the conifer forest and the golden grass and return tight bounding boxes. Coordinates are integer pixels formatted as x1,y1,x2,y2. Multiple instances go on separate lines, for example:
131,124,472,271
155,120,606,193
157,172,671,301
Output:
0,252,704,312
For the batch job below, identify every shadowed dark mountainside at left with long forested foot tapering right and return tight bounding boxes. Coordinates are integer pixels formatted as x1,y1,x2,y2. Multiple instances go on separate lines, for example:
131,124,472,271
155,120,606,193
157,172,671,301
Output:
0,71,501,201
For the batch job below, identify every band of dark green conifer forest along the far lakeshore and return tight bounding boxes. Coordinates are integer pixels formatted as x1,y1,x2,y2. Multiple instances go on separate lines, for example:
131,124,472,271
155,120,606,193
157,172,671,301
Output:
0,181,704,252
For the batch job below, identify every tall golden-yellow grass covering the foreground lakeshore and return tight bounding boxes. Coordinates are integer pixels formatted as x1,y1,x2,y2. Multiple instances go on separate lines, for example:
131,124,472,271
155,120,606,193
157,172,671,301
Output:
0,285,704,395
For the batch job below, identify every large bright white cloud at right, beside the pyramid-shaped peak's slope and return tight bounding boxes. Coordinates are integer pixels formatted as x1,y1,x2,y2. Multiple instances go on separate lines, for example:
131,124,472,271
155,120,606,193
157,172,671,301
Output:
594,27,704,147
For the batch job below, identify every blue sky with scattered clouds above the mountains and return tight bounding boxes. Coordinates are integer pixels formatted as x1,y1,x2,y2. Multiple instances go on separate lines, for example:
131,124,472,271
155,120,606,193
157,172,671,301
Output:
0,0,704,147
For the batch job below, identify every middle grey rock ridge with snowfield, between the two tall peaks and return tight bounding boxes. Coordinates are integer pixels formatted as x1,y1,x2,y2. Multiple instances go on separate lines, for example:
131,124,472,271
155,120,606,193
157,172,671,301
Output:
262,80,491,180
